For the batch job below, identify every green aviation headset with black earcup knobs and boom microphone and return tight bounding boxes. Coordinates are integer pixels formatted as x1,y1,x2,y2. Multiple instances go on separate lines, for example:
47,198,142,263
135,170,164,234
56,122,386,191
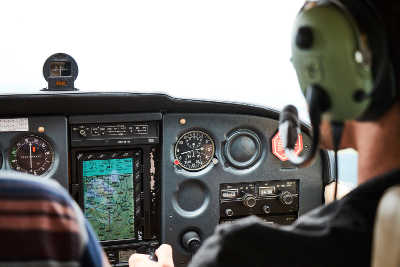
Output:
279,0,399,197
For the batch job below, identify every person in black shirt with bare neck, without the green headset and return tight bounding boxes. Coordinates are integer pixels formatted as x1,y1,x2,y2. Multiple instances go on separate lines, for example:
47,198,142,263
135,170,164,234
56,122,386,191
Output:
130,0,400,267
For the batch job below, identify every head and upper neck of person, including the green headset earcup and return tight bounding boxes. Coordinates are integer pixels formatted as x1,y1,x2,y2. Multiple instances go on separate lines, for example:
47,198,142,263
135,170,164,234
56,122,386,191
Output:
292,0,400,150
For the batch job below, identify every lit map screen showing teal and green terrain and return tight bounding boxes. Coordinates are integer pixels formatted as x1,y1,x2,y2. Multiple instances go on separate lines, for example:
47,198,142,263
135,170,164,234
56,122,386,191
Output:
81,157,136,241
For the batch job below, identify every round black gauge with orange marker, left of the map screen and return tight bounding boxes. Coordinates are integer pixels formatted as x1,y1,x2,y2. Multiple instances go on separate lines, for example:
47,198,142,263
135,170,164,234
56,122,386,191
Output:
8,135,54,175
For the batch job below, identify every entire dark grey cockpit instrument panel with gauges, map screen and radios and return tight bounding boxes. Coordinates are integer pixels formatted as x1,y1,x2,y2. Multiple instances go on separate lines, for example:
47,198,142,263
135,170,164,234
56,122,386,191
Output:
0,94,330,267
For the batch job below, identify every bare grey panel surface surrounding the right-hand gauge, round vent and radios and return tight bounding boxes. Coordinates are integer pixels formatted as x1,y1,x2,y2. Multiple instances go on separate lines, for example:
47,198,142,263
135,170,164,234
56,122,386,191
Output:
161,113,323,266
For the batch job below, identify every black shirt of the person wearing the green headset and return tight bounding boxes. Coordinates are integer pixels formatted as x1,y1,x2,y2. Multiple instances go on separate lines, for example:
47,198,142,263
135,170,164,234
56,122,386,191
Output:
189,171,400,267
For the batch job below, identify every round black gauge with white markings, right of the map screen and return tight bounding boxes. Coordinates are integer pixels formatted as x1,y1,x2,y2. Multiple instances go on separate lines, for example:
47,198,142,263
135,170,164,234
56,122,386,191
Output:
175,131,215,171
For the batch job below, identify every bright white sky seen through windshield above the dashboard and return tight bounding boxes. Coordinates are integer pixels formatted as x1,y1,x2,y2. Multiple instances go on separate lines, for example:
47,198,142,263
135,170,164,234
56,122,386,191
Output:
0,0,305,117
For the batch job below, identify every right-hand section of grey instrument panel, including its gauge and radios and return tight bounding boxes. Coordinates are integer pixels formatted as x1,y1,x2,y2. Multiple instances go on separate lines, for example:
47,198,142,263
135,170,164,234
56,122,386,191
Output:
161,113,324,266
